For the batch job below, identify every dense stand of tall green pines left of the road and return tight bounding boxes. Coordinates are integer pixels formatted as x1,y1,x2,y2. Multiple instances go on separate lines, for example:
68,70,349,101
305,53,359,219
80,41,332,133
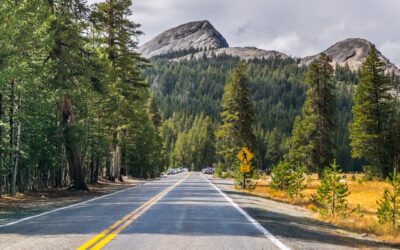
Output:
0,0,162,195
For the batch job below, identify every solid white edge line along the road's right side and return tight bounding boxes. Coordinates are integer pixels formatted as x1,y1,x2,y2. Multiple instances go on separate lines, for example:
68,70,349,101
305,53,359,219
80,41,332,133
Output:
201,175,290,250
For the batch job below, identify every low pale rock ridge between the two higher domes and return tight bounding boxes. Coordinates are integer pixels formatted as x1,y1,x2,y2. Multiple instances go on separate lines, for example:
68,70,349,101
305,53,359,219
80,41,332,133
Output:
174,47,289,61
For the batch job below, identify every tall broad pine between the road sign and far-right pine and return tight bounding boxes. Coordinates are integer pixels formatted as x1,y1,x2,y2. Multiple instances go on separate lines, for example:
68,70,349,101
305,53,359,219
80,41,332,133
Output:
289,54,336,177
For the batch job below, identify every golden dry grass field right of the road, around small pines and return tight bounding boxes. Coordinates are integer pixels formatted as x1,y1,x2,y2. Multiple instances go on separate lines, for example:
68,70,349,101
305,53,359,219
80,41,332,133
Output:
252,174,400,242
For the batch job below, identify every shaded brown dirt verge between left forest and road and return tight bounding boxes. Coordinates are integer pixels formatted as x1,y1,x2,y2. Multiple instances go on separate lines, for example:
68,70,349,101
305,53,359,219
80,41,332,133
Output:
0,179,143,225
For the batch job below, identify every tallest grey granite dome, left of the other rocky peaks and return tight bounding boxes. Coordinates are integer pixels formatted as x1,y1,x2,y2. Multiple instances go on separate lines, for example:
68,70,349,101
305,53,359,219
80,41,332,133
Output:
138,21,229,57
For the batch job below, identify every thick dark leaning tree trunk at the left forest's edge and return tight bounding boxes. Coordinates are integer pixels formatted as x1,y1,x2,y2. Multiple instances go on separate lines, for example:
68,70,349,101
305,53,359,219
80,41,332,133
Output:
59,96,89,190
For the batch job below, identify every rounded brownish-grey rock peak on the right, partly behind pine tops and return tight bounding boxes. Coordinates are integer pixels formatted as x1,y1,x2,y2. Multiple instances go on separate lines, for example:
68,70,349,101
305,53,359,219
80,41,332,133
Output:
301,38,400,75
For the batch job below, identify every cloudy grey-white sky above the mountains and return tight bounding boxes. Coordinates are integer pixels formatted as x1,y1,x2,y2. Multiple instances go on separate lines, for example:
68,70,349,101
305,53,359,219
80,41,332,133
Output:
88,0,400,66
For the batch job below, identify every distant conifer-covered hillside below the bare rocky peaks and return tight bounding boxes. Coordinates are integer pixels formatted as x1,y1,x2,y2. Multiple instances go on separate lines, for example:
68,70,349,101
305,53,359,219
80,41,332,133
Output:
144,54,361,171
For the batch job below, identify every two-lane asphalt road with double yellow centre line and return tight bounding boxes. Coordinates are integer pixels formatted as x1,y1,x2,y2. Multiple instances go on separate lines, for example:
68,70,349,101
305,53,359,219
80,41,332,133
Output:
0,173,285,250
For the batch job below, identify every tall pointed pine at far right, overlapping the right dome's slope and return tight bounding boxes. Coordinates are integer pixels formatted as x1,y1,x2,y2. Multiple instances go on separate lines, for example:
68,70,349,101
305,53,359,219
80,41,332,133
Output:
349,46,392,177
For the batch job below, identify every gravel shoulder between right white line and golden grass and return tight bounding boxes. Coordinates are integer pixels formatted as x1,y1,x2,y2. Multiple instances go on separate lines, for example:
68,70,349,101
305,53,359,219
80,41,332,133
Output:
208,177,400,249
